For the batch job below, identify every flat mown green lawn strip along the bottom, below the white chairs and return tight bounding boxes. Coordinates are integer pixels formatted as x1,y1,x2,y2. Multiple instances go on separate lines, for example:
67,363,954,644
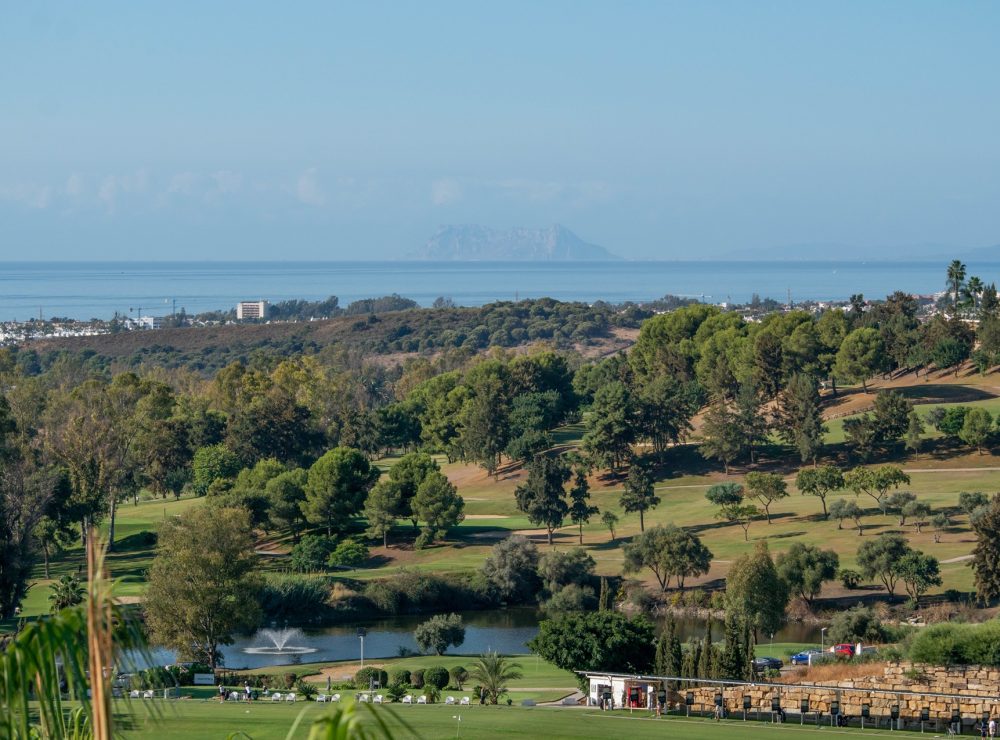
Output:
117,700,952,740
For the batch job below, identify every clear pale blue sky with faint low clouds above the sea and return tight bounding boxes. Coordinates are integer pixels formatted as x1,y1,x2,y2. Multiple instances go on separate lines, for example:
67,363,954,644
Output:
0,0,1000,259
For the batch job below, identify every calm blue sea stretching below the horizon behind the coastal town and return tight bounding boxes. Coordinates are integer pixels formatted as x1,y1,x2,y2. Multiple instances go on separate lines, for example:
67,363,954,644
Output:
0,261,984,321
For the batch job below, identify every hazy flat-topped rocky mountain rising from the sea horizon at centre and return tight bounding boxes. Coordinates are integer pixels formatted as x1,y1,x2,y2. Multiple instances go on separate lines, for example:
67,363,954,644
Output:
411,224,621,261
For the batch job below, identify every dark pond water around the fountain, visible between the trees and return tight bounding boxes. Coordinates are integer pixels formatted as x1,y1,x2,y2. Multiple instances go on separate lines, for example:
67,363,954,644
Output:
145,608,820,669
